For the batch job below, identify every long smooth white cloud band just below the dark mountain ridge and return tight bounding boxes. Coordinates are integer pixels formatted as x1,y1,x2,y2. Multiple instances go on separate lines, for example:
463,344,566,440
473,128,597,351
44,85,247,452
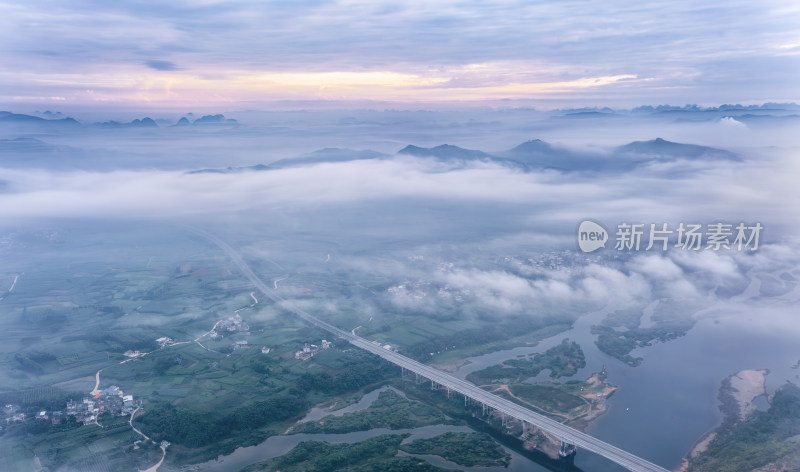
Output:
0,153,780,224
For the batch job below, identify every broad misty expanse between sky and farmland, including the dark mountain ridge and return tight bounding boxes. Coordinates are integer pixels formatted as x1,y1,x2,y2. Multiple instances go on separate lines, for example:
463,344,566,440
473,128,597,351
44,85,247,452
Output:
0,106,800,336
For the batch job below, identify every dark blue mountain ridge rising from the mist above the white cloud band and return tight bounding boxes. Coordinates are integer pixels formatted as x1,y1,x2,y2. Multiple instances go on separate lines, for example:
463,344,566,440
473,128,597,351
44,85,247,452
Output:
189,138,741,177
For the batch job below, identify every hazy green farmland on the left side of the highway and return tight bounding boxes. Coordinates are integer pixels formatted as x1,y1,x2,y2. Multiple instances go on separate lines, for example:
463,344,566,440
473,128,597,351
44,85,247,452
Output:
0,227,404,470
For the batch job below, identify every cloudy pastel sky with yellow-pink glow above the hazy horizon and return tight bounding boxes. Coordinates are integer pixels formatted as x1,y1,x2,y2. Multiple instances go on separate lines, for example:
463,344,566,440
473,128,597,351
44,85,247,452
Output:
0,0,800,109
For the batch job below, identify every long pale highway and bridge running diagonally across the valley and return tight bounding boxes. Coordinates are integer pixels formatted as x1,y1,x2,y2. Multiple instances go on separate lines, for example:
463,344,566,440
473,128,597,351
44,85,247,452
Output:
198,229,668,472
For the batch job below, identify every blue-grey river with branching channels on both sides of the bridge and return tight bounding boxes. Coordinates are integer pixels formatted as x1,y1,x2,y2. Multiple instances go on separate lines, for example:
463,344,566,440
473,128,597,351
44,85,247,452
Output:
195,270,800,472
